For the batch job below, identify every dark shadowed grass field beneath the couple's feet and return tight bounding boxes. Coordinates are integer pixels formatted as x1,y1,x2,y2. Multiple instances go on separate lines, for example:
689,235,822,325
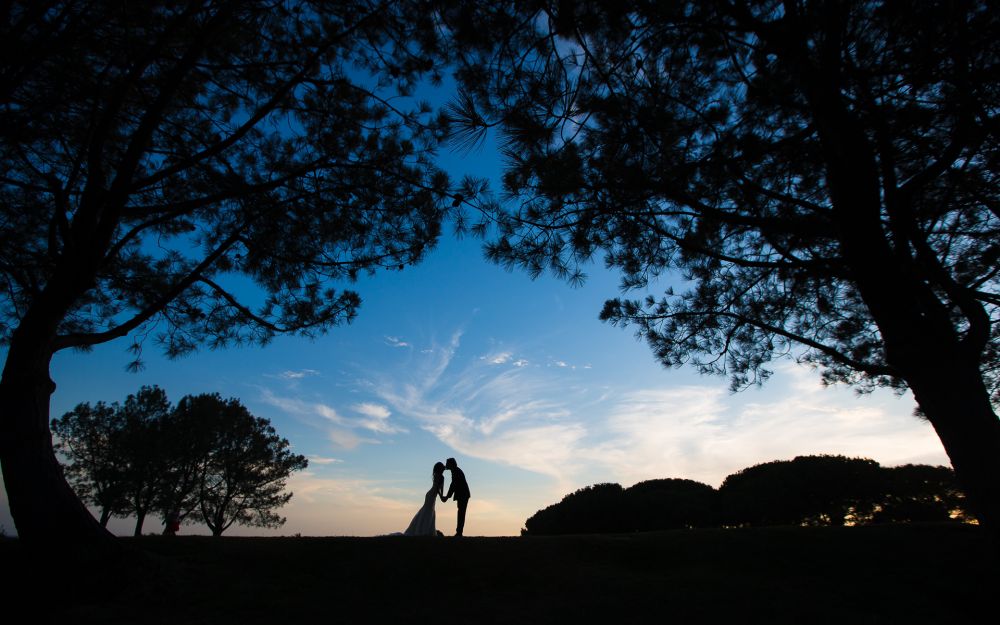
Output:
0,525,1000,625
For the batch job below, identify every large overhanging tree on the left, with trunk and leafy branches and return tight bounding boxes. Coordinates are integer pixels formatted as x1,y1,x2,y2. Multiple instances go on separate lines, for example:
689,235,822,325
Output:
0,0,455,541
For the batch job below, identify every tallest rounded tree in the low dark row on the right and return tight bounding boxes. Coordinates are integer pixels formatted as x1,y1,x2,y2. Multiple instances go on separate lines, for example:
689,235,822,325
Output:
719,456,885,525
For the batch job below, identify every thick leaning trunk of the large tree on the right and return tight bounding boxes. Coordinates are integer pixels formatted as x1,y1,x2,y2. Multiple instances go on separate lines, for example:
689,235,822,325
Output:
804,64,1000,533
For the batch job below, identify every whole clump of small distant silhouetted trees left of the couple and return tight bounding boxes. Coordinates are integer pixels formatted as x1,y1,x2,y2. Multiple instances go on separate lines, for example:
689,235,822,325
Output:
52,386,308,536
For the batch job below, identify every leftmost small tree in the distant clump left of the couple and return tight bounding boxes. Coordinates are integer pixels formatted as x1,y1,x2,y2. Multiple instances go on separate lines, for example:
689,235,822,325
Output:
52,402,127,527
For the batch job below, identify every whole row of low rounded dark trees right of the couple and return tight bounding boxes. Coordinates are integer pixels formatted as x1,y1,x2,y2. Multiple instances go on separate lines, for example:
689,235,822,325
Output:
521,455,972,535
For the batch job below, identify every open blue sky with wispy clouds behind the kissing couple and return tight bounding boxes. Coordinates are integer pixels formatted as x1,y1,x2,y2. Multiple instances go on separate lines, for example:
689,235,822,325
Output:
0,79,948,536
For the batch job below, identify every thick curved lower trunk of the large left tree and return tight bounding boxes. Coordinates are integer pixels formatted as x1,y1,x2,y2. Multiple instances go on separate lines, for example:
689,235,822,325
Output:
0,302,112,544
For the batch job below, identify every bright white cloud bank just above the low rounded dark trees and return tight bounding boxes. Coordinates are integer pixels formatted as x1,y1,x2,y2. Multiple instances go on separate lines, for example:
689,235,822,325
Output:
580,366,948,486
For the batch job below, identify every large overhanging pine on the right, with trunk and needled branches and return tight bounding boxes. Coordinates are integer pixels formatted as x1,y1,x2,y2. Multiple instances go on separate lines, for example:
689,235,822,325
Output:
443,0,1000,527
